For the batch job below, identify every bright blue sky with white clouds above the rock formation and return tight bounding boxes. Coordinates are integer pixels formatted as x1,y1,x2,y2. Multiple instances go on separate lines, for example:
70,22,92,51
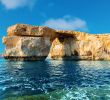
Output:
0,0,110,53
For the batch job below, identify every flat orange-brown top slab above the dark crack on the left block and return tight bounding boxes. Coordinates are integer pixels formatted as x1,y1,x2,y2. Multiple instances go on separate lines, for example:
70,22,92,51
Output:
7,24,55,38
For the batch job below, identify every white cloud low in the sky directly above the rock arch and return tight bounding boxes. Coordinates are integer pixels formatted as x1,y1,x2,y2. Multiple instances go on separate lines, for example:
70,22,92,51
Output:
43,15,88,31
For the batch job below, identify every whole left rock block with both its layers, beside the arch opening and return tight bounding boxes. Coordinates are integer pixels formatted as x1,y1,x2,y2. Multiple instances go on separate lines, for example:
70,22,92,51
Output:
3,24,55,60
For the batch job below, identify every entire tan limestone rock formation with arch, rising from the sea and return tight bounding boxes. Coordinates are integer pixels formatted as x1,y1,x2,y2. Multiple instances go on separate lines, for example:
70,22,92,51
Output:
3,24,110,60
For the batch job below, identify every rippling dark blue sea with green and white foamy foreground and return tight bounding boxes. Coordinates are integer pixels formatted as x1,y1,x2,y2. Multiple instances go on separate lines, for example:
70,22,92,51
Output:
0,59,110,100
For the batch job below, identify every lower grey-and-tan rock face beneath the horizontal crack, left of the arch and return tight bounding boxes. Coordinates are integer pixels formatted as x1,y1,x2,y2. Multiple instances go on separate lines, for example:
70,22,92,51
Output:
3,36,51,60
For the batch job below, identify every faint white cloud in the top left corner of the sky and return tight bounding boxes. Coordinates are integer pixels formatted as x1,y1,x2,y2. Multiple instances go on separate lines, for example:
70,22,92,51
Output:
0,0,36,10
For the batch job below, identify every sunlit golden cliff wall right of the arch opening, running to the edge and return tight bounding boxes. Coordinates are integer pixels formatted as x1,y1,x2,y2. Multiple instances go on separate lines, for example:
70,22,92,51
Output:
49,31,110,60
